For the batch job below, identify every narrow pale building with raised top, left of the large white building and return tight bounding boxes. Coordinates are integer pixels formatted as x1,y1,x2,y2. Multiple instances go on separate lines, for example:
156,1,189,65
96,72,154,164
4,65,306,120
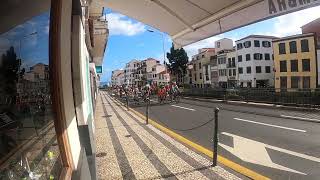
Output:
212,38,233,88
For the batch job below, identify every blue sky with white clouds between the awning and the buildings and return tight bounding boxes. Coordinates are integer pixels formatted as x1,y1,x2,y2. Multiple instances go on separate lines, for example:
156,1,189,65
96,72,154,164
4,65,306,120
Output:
101,6,320,82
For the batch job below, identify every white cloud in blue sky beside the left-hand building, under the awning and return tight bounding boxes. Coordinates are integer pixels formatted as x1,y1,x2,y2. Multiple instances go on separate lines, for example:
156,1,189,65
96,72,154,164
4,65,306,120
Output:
106,13,146,36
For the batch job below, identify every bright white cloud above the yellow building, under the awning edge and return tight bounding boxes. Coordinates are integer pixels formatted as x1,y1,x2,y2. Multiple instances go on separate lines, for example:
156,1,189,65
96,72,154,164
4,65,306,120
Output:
267,6,320,37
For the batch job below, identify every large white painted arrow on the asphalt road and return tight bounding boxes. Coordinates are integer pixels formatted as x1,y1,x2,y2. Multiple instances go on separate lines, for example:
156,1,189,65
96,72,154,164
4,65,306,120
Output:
219,132,308,175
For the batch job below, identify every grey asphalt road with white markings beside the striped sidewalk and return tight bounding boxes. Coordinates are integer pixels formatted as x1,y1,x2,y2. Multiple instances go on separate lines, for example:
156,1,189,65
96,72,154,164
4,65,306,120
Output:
117,95,320,180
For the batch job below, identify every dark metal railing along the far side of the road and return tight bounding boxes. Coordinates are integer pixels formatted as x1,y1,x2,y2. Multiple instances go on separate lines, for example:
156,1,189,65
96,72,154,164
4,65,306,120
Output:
183,88,320,107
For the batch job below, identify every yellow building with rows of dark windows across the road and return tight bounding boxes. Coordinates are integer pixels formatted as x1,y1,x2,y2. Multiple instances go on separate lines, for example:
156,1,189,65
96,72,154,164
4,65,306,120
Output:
273,33,317,91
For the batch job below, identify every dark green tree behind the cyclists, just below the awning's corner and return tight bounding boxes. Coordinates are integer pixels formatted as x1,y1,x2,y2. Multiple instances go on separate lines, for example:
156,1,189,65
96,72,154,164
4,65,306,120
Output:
167,44,189,84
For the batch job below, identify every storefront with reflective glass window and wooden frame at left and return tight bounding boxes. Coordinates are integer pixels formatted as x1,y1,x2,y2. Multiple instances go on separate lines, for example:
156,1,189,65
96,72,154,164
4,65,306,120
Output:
0,0,107,180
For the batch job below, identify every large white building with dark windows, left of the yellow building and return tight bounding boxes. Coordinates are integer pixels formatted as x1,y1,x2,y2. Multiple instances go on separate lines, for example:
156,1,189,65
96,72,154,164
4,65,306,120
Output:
236,35,276,87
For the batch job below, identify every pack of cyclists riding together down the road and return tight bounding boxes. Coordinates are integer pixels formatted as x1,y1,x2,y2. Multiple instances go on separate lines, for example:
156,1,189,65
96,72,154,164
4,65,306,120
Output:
113,82,180,103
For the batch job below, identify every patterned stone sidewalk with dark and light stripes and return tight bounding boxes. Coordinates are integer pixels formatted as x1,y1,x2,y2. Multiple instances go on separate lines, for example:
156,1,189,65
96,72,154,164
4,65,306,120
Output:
95,91,240,179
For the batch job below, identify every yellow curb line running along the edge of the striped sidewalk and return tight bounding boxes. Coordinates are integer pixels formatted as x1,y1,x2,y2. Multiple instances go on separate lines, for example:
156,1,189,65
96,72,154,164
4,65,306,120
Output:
111,94,270,180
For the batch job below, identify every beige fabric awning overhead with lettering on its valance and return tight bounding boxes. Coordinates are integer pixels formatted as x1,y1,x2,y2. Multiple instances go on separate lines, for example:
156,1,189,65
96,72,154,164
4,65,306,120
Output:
105,0,320,47
